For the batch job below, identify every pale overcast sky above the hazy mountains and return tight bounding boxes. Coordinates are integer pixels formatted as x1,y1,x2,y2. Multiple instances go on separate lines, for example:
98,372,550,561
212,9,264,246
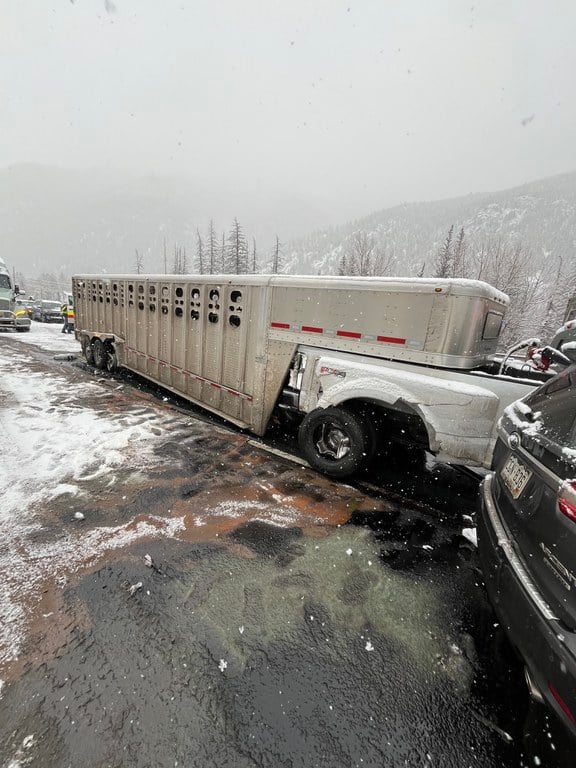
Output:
0,0,576,219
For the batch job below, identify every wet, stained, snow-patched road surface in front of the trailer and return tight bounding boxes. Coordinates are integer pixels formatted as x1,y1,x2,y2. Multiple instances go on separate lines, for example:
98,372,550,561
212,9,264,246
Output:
0,324,560,768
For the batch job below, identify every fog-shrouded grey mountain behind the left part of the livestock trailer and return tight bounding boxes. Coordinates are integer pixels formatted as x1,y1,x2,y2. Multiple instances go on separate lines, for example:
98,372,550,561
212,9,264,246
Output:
0,164,336,277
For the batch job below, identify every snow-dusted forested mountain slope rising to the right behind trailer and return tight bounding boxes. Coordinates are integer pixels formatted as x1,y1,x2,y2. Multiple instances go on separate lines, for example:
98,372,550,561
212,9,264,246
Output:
285,172,576,275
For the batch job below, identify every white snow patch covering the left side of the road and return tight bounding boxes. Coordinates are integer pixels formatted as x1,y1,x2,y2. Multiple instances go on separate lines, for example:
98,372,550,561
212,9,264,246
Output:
0,334,183,665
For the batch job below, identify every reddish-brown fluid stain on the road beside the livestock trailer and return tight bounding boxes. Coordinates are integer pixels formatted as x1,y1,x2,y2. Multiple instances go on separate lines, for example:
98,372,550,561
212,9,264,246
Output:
0,404,378,680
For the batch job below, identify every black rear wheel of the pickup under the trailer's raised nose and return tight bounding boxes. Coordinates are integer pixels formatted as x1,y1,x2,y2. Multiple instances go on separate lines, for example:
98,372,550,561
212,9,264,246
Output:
298,408,372,478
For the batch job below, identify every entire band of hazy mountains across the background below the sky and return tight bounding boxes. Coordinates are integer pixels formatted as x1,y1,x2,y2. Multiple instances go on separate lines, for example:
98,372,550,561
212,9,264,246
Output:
0,164,576,286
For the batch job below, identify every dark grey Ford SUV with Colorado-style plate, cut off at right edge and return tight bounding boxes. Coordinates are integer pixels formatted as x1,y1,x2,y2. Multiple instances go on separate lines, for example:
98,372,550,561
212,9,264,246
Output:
478,365,576,735
